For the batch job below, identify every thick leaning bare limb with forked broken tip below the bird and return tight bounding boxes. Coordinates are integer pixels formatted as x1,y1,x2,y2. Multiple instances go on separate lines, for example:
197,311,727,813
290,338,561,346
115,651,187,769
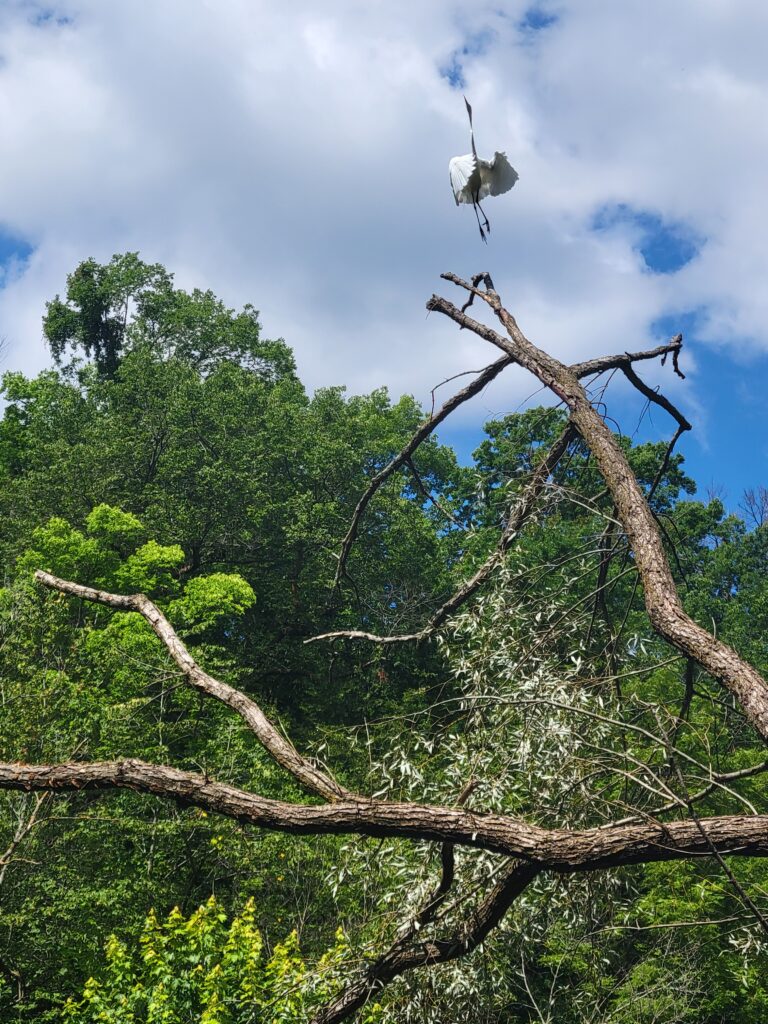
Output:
427,273,768,740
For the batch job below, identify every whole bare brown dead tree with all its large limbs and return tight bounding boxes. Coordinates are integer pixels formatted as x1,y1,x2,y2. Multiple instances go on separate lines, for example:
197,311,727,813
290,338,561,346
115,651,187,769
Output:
0,273,768,1024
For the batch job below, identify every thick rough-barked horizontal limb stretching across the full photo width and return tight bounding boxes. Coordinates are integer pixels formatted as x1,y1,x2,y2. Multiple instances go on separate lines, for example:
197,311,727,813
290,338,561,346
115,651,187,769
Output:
0,760,768,874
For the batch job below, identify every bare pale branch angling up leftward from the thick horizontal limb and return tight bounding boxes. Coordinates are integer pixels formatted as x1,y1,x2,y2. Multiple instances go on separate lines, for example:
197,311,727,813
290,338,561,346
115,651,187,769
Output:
35,569,352,801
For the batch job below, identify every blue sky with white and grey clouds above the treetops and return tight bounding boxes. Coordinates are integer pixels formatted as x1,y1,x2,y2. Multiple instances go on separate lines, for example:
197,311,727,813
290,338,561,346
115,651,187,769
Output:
0,0,768,506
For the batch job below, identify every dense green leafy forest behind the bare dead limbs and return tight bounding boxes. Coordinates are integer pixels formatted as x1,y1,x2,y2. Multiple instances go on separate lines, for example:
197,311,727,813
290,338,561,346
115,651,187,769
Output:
0,254,768,1024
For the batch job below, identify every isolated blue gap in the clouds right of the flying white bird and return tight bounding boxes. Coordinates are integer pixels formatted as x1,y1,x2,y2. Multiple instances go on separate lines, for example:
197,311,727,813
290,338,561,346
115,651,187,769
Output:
592,203,705,273
